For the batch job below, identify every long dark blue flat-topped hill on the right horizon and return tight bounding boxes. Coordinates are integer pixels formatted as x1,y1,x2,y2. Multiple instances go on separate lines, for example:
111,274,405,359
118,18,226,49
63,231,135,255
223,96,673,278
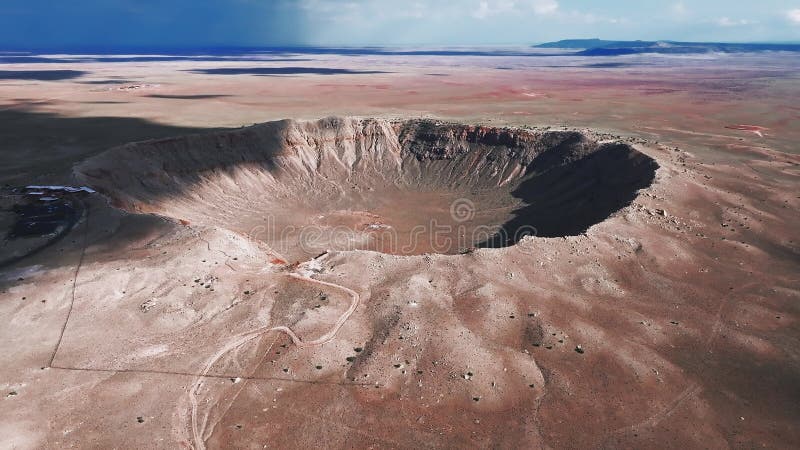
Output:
534,39,800,56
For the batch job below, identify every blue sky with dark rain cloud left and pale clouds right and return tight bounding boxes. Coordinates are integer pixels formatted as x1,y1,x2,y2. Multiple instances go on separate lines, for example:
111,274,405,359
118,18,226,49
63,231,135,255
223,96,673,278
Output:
0,0,800,50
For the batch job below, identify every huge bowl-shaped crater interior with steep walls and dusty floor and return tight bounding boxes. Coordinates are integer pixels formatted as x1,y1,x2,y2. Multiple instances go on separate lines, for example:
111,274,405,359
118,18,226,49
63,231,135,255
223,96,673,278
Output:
76,118,658,260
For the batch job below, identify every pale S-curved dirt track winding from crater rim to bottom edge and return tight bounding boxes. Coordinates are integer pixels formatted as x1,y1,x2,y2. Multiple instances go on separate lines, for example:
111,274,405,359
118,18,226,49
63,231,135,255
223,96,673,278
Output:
189,264,361,450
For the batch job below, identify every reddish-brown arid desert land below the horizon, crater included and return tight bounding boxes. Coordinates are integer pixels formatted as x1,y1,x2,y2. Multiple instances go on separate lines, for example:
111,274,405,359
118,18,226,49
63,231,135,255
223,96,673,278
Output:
0,48,800,449
